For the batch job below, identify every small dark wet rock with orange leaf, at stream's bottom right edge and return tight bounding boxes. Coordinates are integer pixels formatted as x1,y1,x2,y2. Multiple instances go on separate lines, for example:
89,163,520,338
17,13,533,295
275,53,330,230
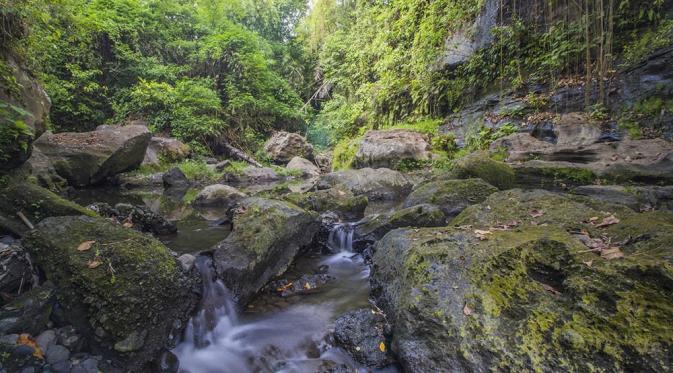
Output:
334,308,395,368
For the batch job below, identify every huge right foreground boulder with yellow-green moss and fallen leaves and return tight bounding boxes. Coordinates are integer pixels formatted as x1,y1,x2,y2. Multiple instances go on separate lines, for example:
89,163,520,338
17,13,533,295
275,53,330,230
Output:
371,190,673,372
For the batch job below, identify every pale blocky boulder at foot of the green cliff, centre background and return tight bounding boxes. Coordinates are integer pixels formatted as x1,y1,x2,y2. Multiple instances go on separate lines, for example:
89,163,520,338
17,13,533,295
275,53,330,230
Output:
354,130,430,169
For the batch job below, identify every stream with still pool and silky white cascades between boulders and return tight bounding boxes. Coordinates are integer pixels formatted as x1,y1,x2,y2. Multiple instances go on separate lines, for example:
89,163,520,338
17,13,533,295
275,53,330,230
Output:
69,185,397,373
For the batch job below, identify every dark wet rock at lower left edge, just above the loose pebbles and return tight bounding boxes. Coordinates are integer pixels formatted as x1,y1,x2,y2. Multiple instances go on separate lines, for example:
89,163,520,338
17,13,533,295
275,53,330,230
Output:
0,286,55,335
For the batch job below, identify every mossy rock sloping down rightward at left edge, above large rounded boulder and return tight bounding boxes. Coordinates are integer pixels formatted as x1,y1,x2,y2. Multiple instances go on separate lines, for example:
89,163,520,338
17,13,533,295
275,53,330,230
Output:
0,180,96,236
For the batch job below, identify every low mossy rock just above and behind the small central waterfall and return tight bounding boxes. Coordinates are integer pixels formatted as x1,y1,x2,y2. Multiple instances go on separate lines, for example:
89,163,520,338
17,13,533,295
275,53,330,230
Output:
285,188,369,220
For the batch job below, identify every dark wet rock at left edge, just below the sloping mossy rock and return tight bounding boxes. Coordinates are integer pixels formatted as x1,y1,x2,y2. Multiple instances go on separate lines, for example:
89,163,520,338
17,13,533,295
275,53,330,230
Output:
0,236,38,296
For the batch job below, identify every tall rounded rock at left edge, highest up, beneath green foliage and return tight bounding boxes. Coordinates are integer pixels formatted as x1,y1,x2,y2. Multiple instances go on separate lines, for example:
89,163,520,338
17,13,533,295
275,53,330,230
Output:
0,52,51,170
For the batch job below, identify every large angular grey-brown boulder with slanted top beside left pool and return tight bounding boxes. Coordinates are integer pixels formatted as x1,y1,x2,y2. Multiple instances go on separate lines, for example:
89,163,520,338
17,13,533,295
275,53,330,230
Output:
35,125,151,186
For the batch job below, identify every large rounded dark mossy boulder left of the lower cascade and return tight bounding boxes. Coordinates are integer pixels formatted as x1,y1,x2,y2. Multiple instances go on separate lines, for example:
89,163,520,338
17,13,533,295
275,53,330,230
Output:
24,216,195,371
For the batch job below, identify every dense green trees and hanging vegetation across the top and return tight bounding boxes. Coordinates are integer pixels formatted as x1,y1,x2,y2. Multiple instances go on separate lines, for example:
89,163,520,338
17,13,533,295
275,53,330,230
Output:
0,0,673,158
